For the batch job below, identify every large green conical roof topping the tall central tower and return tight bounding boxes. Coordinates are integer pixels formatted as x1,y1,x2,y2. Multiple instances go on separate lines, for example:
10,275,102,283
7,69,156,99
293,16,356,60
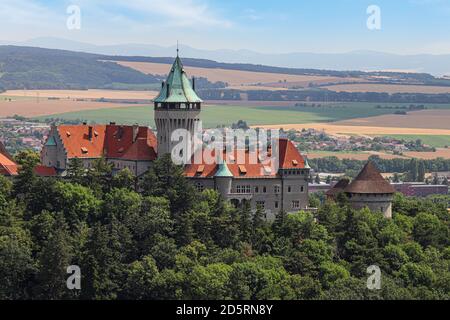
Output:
153,55,203,103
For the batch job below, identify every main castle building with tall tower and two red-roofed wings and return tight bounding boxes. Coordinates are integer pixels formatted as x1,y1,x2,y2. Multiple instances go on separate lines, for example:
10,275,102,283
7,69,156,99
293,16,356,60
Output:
41,55,310,219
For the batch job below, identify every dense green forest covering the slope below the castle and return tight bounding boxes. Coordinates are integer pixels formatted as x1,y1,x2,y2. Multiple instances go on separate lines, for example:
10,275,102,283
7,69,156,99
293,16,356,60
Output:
0,151,450,300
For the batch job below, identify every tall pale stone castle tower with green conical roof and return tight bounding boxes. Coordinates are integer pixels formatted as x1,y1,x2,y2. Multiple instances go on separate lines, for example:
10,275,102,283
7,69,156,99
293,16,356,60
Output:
153,50,203,159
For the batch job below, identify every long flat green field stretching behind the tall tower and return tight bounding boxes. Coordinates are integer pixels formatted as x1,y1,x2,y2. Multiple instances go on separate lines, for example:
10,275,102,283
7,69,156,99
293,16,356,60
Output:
34,102,450,128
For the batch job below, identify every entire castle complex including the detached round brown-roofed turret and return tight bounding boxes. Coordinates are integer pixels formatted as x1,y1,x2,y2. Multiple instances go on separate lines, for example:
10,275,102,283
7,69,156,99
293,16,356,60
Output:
0,55,395,219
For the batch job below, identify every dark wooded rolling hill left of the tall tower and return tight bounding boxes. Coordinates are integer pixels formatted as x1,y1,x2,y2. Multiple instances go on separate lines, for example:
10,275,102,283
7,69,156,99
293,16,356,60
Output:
0,46,160,89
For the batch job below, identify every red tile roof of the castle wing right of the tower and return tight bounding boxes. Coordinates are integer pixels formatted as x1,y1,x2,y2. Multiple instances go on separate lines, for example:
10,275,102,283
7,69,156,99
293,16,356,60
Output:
184,139,305,178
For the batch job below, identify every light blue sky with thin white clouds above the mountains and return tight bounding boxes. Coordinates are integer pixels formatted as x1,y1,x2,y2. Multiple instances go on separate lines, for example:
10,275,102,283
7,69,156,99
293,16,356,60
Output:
0,0,450,54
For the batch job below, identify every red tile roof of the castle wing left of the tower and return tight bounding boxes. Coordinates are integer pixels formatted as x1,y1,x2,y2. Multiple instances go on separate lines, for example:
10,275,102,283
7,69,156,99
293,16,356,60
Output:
58,125,157,160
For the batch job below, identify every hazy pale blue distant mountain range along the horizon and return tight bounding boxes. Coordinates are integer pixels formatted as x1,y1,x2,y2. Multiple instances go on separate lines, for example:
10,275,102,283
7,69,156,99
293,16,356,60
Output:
0,38,450,76
